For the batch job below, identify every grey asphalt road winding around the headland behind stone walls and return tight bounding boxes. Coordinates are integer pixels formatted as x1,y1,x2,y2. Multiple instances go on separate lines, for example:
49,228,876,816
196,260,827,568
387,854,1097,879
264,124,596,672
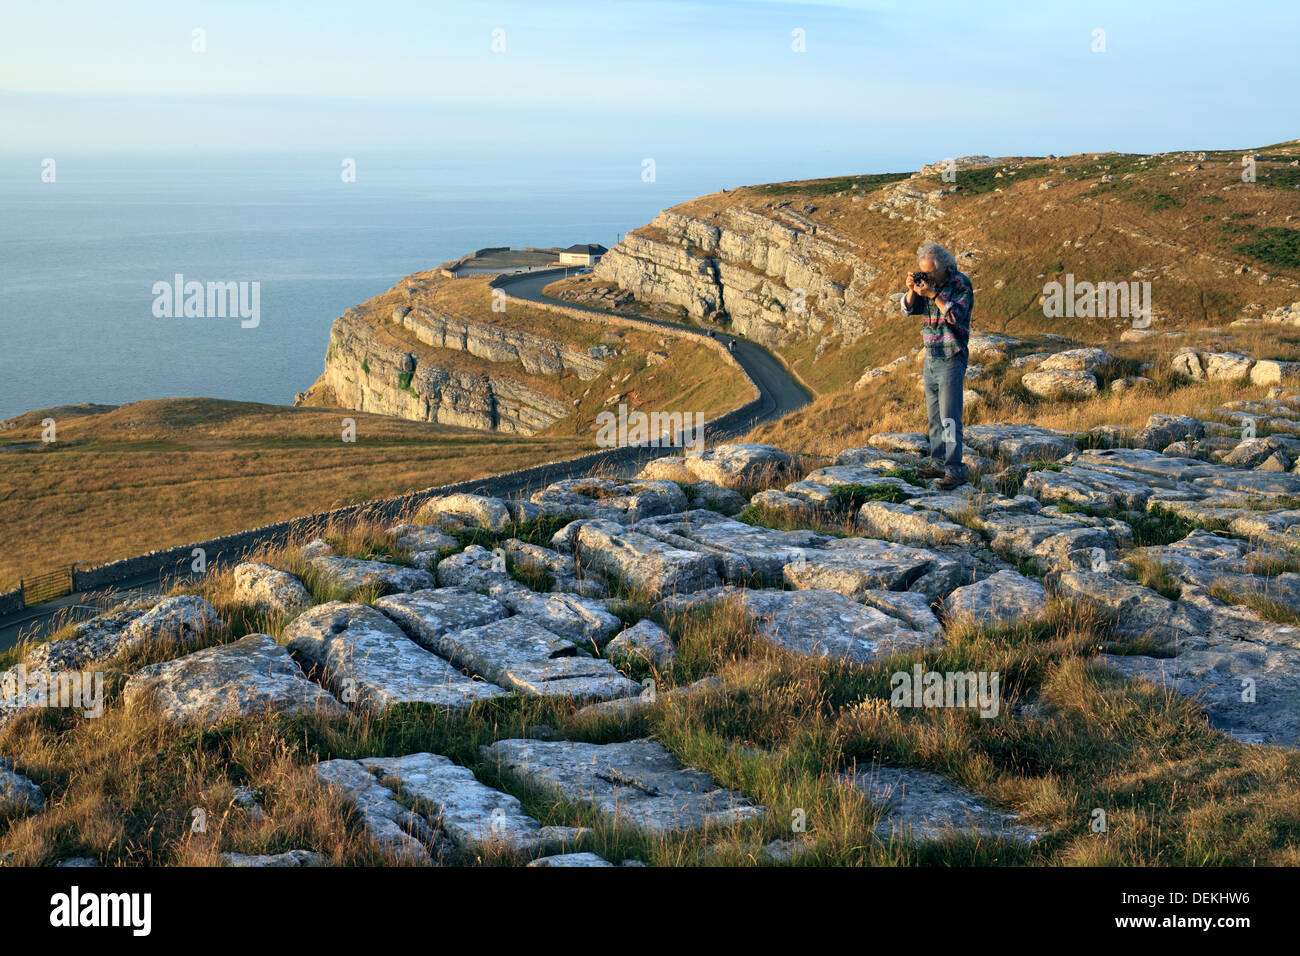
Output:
0,269,810,650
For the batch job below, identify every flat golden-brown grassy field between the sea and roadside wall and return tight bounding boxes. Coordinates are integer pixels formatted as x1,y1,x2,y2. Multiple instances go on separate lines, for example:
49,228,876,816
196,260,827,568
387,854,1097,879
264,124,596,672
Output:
0,398,592,589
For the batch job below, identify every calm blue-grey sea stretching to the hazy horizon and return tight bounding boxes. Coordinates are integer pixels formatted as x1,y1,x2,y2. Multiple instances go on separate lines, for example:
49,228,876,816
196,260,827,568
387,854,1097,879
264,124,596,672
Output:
0,151,894,419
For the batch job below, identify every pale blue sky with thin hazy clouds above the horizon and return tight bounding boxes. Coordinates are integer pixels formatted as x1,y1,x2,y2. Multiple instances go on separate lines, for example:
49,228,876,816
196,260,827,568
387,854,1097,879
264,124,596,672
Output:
0,0,1300,170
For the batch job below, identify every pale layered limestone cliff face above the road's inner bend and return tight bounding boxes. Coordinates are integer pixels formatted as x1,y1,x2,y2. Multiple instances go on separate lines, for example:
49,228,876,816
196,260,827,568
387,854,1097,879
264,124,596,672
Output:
594,202,885,345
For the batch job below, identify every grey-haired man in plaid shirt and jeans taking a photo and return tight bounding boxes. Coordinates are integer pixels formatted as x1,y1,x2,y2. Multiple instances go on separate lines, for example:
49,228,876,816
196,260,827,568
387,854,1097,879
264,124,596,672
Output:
900,242,975,490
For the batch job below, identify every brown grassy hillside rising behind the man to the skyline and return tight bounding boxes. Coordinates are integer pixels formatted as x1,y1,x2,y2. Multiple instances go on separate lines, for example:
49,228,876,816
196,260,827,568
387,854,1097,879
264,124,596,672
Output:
556,140,1300,403
